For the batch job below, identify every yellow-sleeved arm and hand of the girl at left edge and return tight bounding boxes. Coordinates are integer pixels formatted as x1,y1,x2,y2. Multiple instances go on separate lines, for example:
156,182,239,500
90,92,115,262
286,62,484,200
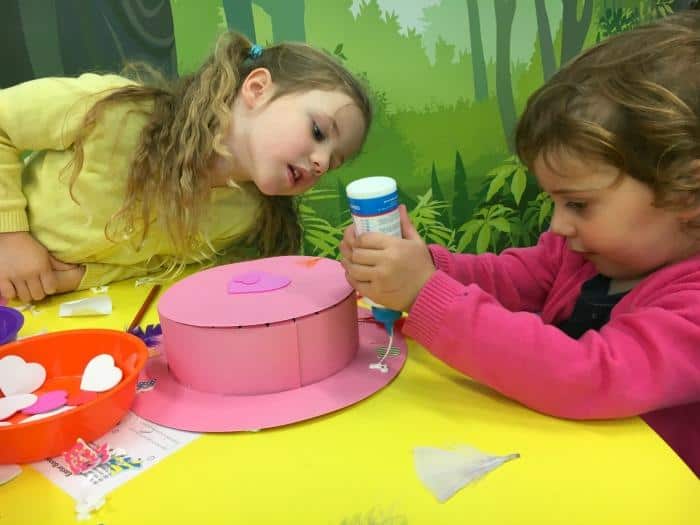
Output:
0,75,128,302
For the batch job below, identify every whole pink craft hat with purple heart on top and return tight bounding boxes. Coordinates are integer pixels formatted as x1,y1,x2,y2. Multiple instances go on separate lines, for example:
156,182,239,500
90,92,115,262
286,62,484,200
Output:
133,256,406,432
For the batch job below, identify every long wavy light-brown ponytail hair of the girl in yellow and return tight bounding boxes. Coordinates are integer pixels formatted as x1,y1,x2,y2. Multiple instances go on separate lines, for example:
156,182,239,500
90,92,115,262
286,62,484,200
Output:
69,32,372,264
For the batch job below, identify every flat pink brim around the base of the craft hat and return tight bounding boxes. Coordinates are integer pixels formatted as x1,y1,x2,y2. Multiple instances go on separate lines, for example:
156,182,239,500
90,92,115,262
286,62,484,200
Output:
132,321,407,432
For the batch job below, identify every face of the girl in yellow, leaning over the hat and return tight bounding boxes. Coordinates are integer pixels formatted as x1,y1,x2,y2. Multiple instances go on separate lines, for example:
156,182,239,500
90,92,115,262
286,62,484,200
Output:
228,72,365,195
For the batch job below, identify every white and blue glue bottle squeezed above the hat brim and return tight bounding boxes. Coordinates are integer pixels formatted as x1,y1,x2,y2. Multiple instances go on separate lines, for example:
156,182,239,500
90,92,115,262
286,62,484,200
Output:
345,177,401,373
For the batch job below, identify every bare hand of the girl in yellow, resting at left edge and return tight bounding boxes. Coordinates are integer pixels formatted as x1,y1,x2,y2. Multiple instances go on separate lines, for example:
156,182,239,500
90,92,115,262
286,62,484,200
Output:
0,232,84,303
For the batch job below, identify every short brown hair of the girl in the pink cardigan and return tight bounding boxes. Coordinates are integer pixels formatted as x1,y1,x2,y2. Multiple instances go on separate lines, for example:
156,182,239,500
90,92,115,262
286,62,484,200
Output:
515,11,700,219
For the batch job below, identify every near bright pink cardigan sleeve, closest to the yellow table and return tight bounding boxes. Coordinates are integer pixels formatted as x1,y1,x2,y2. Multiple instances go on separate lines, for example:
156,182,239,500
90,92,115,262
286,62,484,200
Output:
403,271,700,419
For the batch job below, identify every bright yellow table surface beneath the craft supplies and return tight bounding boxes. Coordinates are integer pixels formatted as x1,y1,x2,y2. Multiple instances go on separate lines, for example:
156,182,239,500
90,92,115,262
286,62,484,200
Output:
0,281,700,525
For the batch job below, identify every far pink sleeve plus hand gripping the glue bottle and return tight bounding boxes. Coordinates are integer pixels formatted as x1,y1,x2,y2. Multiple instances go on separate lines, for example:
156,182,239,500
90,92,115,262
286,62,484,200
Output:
340,206,564,312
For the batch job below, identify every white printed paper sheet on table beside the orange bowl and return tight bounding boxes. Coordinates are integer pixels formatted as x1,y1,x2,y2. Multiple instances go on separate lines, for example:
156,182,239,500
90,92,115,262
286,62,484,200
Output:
31,412,201,500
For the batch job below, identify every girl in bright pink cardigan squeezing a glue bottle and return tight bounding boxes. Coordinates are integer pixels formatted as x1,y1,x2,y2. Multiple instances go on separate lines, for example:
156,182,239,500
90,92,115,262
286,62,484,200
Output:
341,11,700,474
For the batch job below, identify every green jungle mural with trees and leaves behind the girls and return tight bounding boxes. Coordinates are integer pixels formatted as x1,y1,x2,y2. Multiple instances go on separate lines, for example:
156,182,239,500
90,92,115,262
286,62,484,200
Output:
0,0,690,257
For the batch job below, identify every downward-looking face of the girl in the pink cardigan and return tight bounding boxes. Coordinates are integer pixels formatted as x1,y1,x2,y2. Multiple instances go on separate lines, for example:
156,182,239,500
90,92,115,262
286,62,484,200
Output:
534,154,699,279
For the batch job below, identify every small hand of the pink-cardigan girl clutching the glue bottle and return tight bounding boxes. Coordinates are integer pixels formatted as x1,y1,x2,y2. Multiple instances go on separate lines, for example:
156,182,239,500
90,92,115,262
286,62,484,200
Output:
340,205,435,310
